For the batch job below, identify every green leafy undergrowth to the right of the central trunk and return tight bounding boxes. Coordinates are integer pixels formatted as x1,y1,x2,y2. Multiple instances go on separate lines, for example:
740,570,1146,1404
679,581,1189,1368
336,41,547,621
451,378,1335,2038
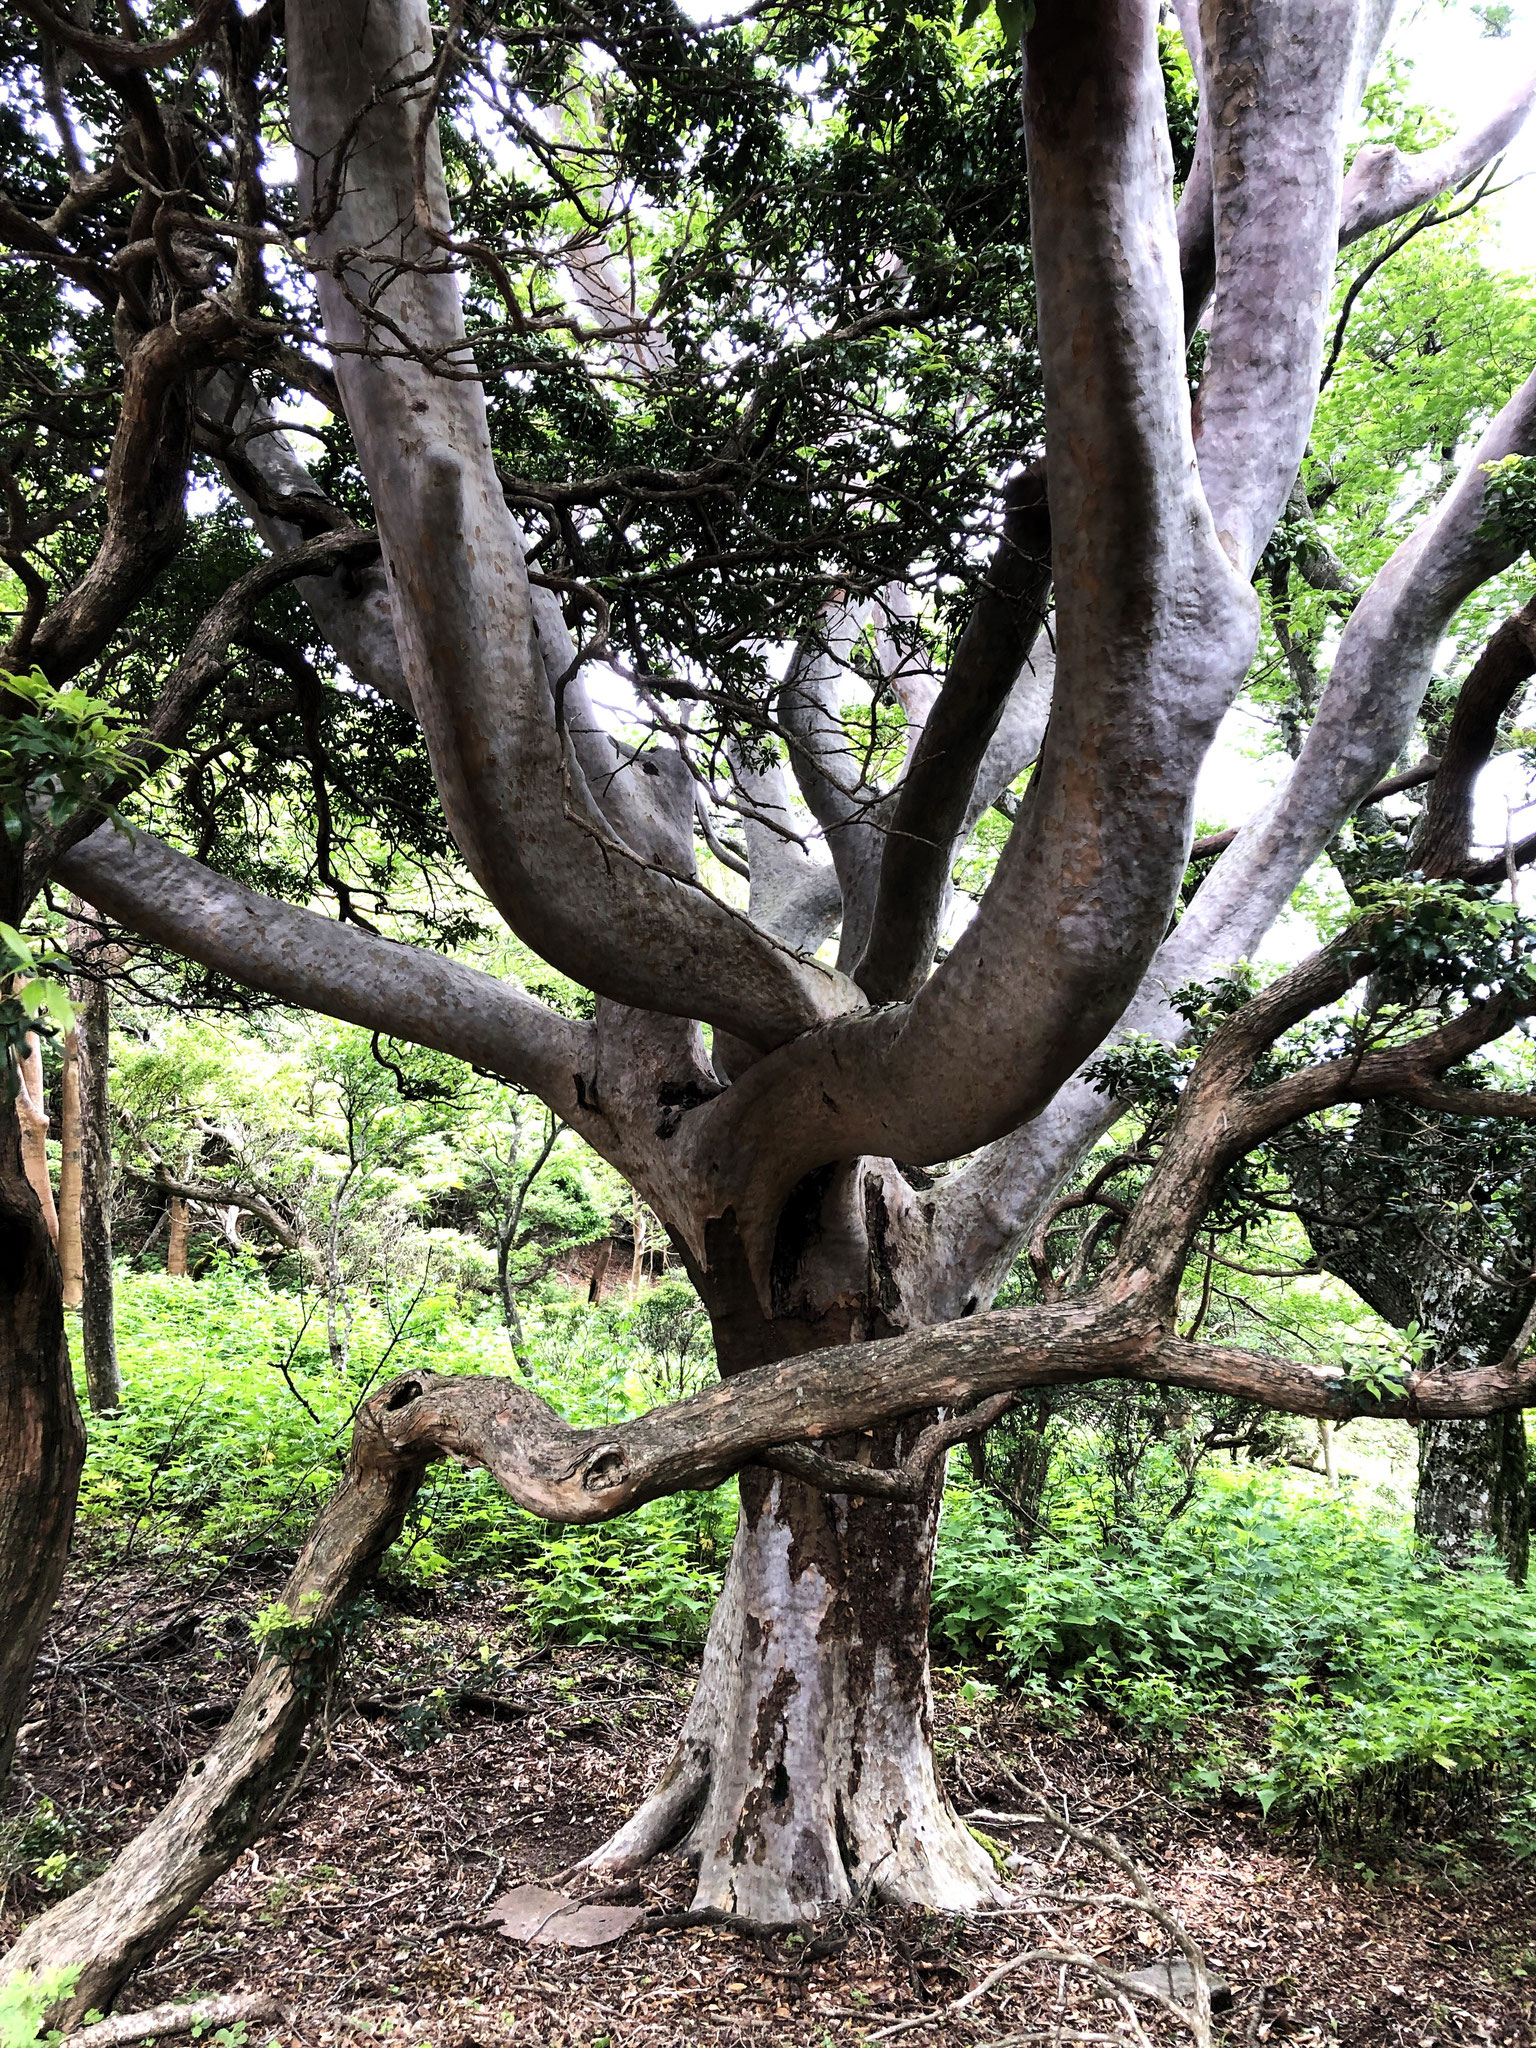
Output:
934,1475,1536,1835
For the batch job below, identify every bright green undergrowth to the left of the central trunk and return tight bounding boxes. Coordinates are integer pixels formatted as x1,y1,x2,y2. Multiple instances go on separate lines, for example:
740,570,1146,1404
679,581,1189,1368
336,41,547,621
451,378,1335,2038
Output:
80,1266,735,1649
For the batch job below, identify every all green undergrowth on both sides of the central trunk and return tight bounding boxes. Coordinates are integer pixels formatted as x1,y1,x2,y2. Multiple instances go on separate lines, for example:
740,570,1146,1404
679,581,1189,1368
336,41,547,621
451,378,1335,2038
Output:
82,1270,1536,1849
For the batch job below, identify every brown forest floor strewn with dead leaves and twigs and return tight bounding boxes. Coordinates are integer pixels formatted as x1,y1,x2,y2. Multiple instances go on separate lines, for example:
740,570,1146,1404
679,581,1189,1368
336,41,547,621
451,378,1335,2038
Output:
0,1565,1536,2048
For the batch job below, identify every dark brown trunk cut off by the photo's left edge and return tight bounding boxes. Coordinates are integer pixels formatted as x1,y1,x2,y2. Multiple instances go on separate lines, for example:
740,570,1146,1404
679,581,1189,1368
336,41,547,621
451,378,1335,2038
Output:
0,1090,86,1786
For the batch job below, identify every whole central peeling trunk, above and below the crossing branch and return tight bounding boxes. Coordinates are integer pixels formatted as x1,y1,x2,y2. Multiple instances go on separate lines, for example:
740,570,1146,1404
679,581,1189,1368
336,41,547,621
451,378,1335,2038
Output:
590,1196,1001,1921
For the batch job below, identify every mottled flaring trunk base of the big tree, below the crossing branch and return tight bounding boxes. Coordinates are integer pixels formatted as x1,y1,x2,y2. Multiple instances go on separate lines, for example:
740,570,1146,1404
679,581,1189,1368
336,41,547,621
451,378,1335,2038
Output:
590,1441,1004,1921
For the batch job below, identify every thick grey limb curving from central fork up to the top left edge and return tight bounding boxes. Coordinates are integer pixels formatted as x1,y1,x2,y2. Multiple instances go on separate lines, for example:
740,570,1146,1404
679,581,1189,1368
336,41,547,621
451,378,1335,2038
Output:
289,0,862,1044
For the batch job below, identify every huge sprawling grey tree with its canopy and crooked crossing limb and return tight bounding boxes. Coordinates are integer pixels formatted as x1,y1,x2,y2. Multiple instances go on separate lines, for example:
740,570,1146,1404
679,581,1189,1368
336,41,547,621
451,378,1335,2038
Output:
4,0,1536,2003
